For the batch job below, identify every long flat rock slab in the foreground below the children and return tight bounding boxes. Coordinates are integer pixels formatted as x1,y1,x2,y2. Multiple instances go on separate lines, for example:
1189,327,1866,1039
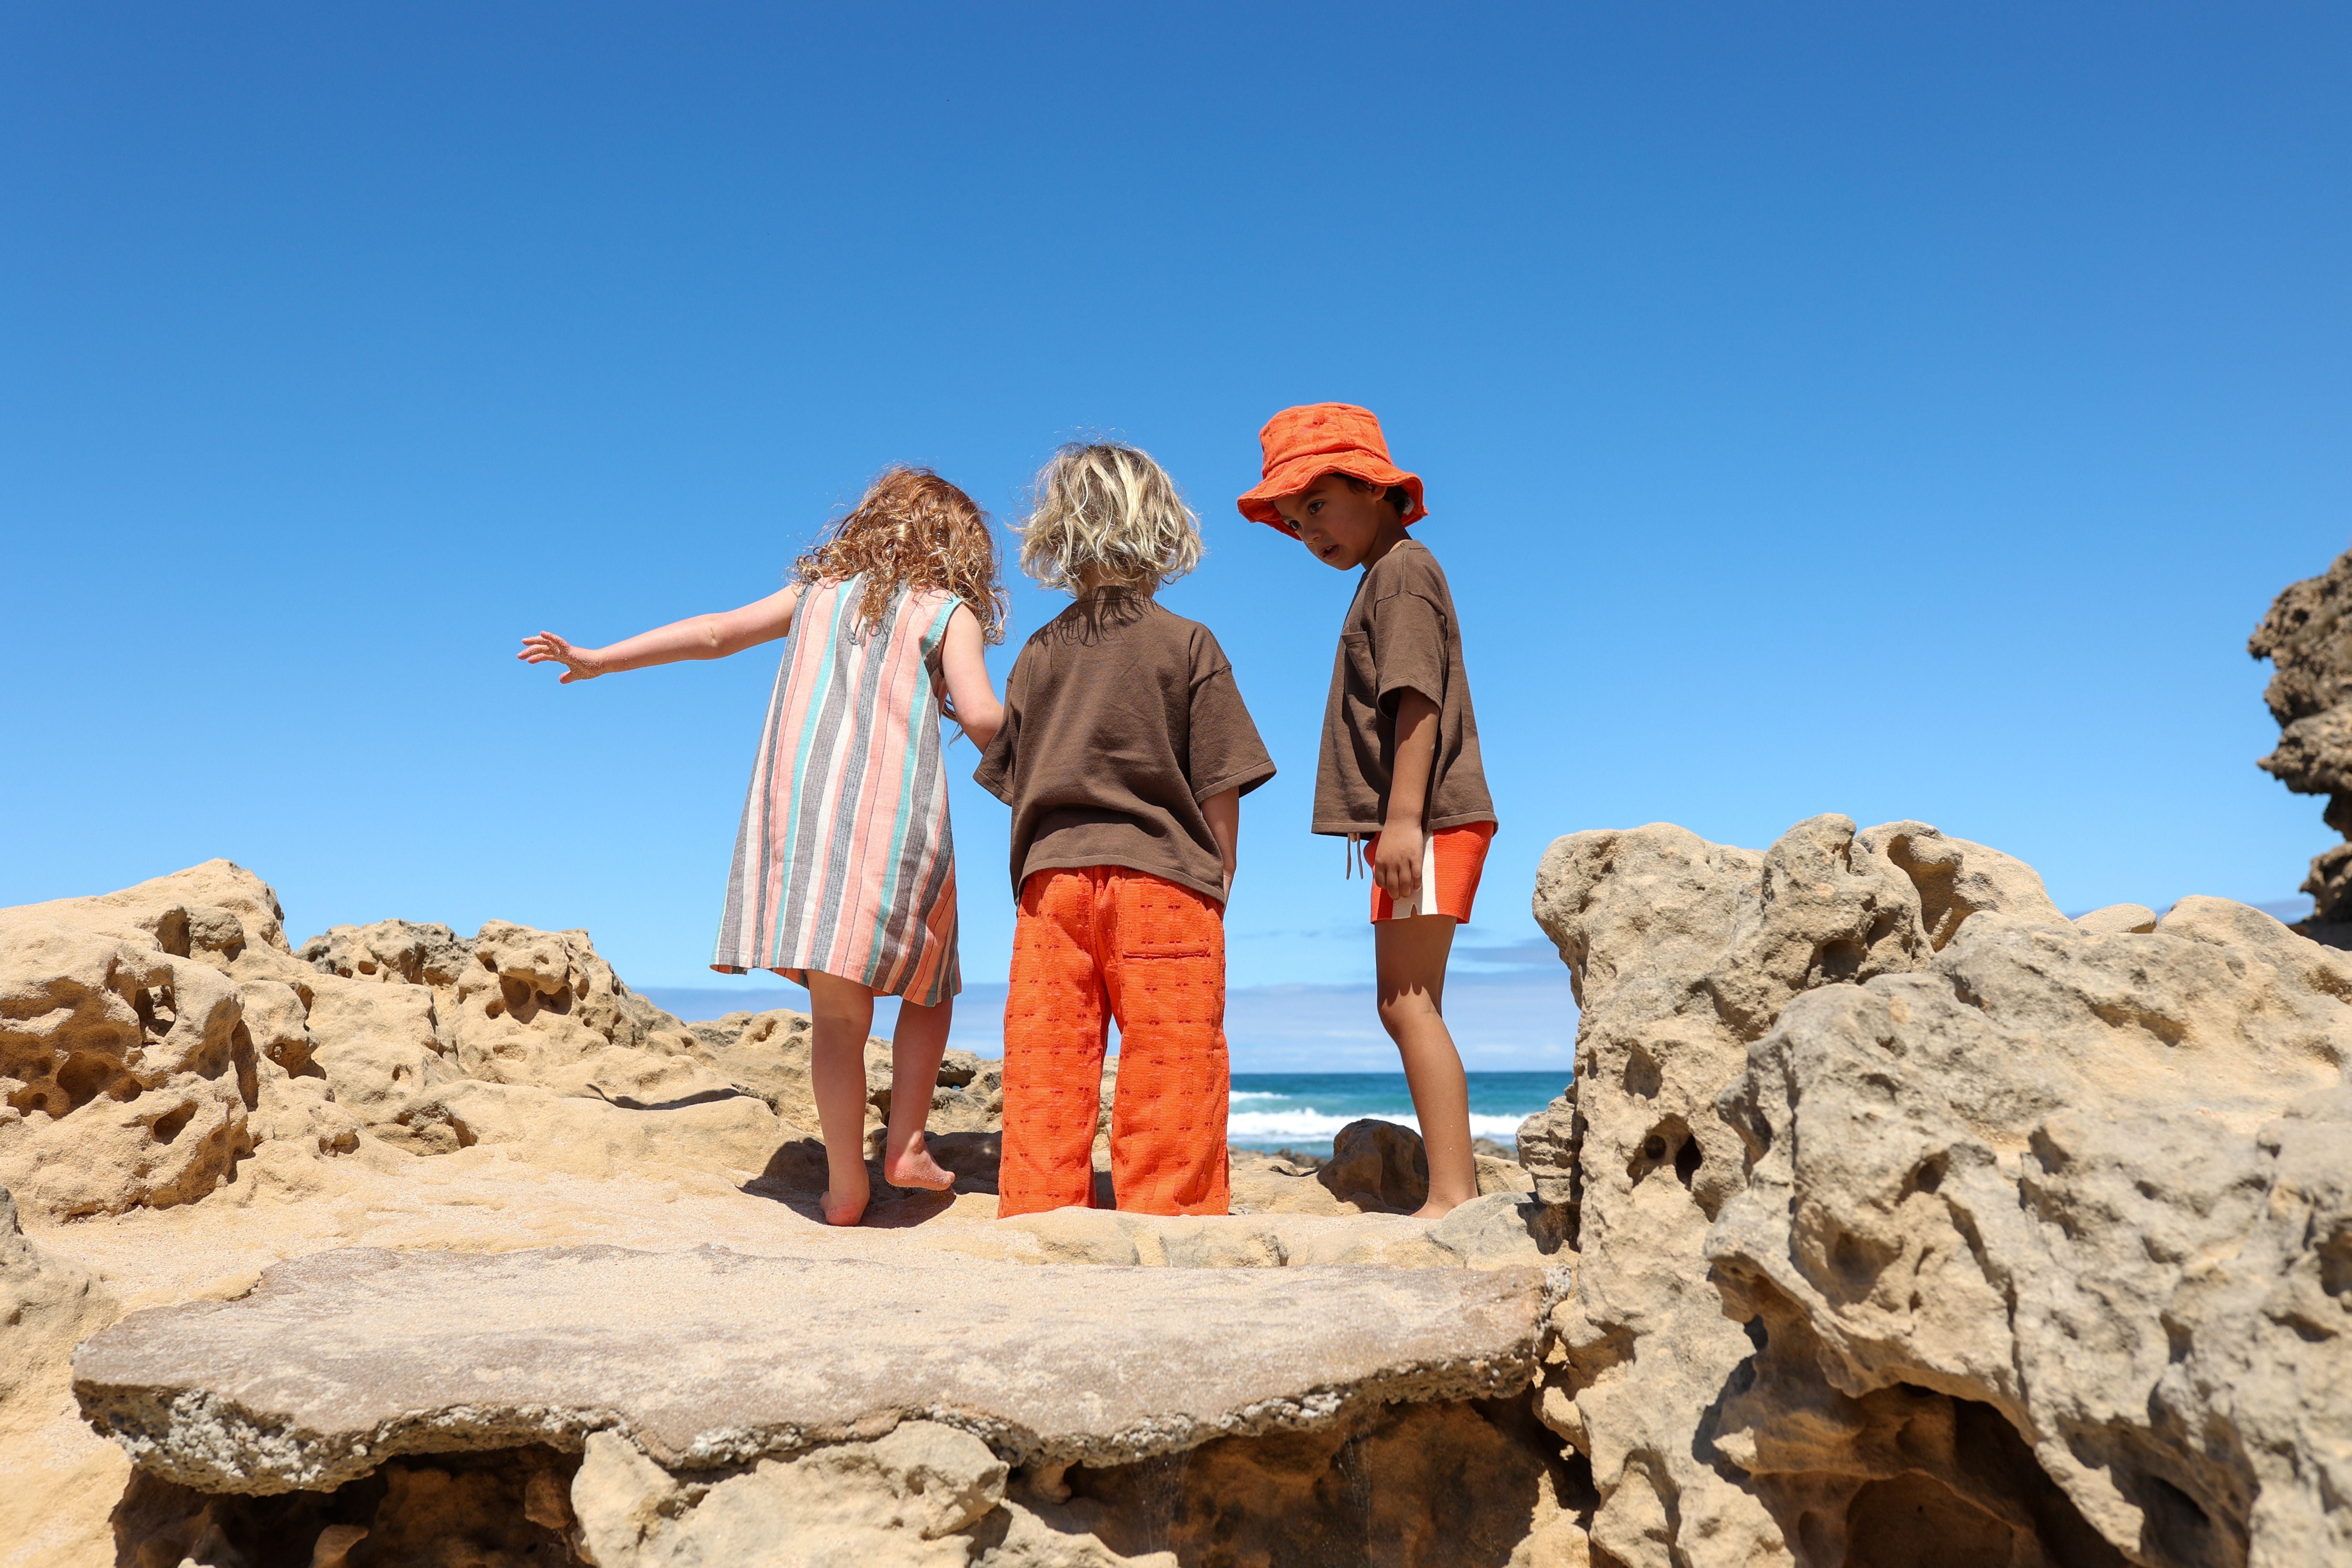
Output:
75,1246,1543,1493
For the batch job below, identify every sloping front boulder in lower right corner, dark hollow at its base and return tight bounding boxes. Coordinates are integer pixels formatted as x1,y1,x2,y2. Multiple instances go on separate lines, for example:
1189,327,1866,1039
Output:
1708,898,2352,1568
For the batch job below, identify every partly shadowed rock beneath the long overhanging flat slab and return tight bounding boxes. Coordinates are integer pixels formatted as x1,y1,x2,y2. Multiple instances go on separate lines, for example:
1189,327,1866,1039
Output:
113,1399,1588,1568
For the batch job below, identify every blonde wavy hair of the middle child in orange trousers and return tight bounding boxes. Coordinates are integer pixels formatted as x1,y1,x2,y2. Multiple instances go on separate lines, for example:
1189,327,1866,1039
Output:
1014,442,1202,595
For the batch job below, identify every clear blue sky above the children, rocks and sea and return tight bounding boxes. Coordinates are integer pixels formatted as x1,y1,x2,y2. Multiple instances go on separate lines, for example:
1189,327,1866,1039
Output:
0,2,2352,1067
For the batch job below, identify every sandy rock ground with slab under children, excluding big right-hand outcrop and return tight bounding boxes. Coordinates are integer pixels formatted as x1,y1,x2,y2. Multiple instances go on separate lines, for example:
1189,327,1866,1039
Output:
0,863,1583,1568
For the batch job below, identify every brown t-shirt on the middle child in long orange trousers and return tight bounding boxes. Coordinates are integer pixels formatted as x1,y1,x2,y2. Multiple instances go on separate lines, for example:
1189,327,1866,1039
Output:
972,592,1275,903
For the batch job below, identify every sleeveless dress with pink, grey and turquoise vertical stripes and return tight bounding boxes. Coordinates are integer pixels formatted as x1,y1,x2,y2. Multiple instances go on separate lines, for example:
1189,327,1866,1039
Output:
710,578,962,1006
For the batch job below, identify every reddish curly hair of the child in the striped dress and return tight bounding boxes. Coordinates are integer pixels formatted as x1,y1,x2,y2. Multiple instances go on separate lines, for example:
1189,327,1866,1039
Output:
792,468,1004,642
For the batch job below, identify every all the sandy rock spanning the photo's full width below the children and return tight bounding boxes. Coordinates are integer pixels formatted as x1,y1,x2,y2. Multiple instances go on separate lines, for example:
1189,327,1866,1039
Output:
0,816,2352,1568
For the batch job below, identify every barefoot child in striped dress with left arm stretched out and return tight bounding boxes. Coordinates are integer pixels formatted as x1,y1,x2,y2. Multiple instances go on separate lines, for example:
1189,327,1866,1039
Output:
520,468,1004,1225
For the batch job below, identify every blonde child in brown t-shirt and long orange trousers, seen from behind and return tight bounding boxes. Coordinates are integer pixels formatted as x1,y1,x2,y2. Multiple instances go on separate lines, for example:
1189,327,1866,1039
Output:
974,442,1275,1216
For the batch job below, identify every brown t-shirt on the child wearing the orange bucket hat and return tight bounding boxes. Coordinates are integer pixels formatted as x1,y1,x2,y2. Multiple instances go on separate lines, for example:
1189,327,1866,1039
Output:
1315,538,1493,835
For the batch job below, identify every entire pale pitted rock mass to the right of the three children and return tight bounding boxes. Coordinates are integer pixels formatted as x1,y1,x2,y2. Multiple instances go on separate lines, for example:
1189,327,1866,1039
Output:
1519,816,2352,1568
